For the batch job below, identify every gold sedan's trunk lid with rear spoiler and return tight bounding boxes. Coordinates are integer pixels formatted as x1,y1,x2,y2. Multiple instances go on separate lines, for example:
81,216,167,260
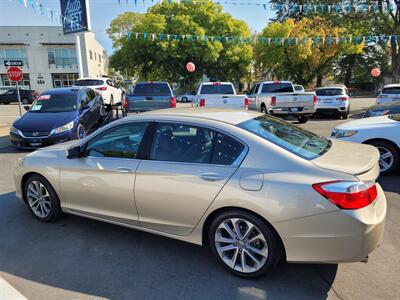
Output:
312,140,379,180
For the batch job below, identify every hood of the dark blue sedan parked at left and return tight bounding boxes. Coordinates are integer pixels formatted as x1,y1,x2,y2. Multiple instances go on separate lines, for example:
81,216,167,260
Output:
13,111,78,131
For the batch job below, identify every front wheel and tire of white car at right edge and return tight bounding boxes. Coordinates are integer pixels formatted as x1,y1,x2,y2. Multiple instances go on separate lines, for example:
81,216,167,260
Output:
367,140,400,175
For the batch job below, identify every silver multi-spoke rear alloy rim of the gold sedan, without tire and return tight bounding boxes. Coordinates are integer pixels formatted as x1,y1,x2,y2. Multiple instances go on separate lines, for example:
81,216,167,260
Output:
215,218,268,273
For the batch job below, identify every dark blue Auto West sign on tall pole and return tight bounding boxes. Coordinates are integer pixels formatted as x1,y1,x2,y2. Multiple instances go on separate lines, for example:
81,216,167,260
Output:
60,0,89,34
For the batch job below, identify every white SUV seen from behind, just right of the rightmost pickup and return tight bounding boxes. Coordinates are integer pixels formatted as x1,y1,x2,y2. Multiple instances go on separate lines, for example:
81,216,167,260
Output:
315,86,350,119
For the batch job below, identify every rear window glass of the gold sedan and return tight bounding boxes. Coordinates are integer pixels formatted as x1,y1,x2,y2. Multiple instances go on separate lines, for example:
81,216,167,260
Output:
237,115,331,160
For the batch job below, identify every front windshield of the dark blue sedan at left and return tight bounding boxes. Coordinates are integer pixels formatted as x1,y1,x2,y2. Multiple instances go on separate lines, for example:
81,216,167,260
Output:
29,95,78,113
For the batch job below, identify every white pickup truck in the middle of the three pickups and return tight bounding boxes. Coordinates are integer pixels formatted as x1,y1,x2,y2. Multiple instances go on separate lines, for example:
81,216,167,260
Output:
194,82,249,109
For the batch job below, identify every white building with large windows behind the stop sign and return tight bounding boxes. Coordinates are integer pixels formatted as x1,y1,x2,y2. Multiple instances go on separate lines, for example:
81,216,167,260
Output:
0,26,108,92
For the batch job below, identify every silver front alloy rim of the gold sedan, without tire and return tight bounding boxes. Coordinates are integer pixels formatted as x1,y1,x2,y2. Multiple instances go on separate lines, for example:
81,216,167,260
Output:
26,180,51,219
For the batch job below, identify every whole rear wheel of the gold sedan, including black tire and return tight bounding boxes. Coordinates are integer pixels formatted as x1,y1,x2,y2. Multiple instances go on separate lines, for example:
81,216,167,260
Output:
208,210,283,278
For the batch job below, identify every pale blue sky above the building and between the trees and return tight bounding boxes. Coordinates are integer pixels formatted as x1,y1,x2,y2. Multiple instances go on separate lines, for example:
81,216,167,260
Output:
0,0,272,54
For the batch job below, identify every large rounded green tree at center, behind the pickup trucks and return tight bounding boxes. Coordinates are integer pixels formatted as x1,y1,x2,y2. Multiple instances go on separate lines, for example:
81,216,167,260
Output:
109,0,252,86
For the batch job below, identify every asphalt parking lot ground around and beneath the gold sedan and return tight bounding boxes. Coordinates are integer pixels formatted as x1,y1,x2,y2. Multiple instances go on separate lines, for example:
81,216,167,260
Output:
0,98,400,300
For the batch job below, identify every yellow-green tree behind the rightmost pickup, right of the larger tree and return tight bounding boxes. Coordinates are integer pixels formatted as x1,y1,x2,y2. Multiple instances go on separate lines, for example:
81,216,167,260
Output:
255,17,363,85
